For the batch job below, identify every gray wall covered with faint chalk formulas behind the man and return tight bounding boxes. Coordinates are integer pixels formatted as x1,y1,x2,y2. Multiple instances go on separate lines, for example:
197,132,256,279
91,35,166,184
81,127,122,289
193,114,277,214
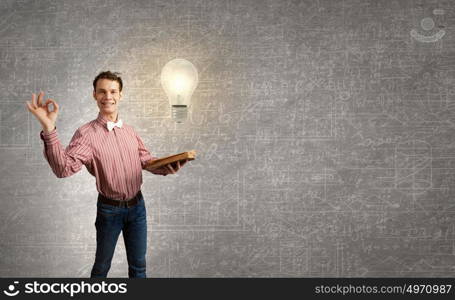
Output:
0,0,455,277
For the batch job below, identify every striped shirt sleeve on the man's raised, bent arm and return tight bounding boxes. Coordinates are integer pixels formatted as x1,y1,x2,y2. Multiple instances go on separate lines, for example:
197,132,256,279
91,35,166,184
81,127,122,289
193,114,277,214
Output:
40,129,93,178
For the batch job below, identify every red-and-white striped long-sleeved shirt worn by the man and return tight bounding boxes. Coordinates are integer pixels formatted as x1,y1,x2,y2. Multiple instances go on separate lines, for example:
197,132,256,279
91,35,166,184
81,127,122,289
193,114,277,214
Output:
41,114,156,200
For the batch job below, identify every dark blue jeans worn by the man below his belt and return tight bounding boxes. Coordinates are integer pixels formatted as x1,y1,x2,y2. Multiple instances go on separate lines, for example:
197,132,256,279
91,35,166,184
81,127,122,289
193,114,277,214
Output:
91,196,147,278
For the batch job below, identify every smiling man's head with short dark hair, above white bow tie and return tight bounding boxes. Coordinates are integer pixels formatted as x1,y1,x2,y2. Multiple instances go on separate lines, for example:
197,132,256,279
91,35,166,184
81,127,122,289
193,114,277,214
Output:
93,71,123,116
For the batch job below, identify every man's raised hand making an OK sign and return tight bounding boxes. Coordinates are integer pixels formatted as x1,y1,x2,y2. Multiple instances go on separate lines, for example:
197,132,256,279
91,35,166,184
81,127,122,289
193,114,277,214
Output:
25,92,58,132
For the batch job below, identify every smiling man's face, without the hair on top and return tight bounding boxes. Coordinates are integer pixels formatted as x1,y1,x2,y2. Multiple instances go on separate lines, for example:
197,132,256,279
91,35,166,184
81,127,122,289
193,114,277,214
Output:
93,79,122,115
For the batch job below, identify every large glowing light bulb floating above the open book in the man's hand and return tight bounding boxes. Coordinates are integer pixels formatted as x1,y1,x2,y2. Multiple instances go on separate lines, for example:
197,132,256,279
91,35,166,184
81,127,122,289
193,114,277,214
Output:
161,58,198,123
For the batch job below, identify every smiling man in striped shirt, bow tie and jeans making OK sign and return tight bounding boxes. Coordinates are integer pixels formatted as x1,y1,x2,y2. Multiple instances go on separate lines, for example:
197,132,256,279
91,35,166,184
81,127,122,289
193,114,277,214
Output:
26,71,186,277
